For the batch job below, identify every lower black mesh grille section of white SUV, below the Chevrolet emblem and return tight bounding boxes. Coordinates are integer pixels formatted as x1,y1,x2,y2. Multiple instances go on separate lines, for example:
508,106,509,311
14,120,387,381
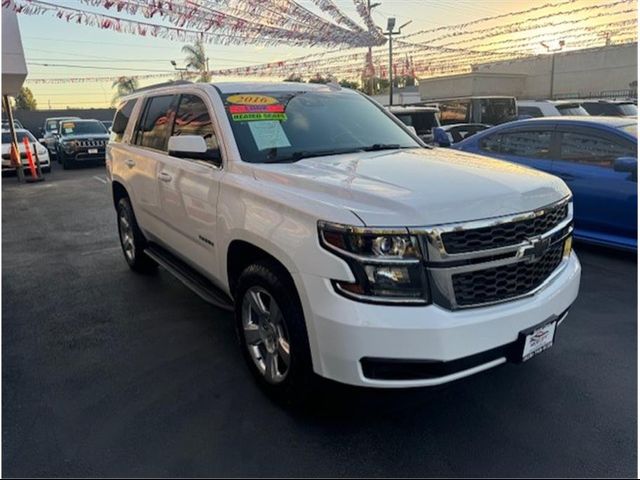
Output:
452,242,564,307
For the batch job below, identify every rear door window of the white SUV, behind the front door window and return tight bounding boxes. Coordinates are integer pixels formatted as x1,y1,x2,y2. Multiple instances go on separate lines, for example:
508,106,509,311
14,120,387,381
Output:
134,95,174,151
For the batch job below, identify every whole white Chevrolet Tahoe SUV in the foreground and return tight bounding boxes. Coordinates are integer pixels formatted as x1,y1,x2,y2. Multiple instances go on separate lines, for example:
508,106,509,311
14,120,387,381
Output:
107,82,580,399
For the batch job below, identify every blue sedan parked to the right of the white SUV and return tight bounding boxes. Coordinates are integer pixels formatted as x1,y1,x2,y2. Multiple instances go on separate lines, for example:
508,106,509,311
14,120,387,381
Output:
453,116,638,250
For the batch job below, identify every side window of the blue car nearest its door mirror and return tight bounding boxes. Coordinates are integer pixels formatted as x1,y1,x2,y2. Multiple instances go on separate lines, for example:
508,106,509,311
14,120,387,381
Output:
560,132,638,168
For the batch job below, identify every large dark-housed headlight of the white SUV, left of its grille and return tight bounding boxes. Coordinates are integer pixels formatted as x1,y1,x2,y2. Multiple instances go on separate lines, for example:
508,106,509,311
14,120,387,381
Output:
318,221,429,305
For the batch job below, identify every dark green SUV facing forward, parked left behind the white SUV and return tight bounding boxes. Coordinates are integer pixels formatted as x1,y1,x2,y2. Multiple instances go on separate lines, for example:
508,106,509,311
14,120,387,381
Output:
56,119,109,170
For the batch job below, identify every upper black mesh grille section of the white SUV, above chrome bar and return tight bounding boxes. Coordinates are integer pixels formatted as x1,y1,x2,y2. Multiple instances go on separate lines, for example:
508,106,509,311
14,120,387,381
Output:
442,203,569,253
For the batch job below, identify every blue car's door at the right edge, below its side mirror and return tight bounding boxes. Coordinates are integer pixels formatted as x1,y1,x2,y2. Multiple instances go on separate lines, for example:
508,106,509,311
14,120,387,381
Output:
554,126,638,244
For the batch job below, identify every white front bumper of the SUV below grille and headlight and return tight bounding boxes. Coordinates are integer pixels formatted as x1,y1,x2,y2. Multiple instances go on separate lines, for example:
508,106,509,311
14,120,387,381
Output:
294,249,581,388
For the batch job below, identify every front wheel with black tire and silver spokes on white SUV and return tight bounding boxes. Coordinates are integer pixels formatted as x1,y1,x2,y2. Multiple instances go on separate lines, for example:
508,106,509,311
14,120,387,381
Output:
235,261,320,405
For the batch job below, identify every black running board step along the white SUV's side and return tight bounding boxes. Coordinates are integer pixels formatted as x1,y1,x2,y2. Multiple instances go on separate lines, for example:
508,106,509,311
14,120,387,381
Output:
144,244,233,311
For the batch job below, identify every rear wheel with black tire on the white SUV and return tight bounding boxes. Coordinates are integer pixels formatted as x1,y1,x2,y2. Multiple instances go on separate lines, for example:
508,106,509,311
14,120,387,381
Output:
116,197,158,274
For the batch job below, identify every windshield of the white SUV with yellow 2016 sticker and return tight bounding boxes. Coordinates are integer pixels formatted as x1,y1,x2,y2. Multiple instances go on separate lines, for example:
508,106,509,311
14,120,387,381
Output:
222,90,420,163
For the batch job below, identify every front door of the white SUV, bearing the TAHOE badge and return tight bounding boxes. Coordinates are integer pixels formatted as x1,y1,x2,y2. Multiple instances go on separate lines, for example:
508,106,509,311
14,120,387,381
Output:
158,91,223,279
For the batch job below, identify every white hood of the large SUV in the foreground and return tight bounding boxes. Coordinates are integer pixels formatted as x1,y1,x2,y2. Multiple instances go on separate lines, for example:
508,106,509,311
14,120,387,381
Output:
254,148,570,227
